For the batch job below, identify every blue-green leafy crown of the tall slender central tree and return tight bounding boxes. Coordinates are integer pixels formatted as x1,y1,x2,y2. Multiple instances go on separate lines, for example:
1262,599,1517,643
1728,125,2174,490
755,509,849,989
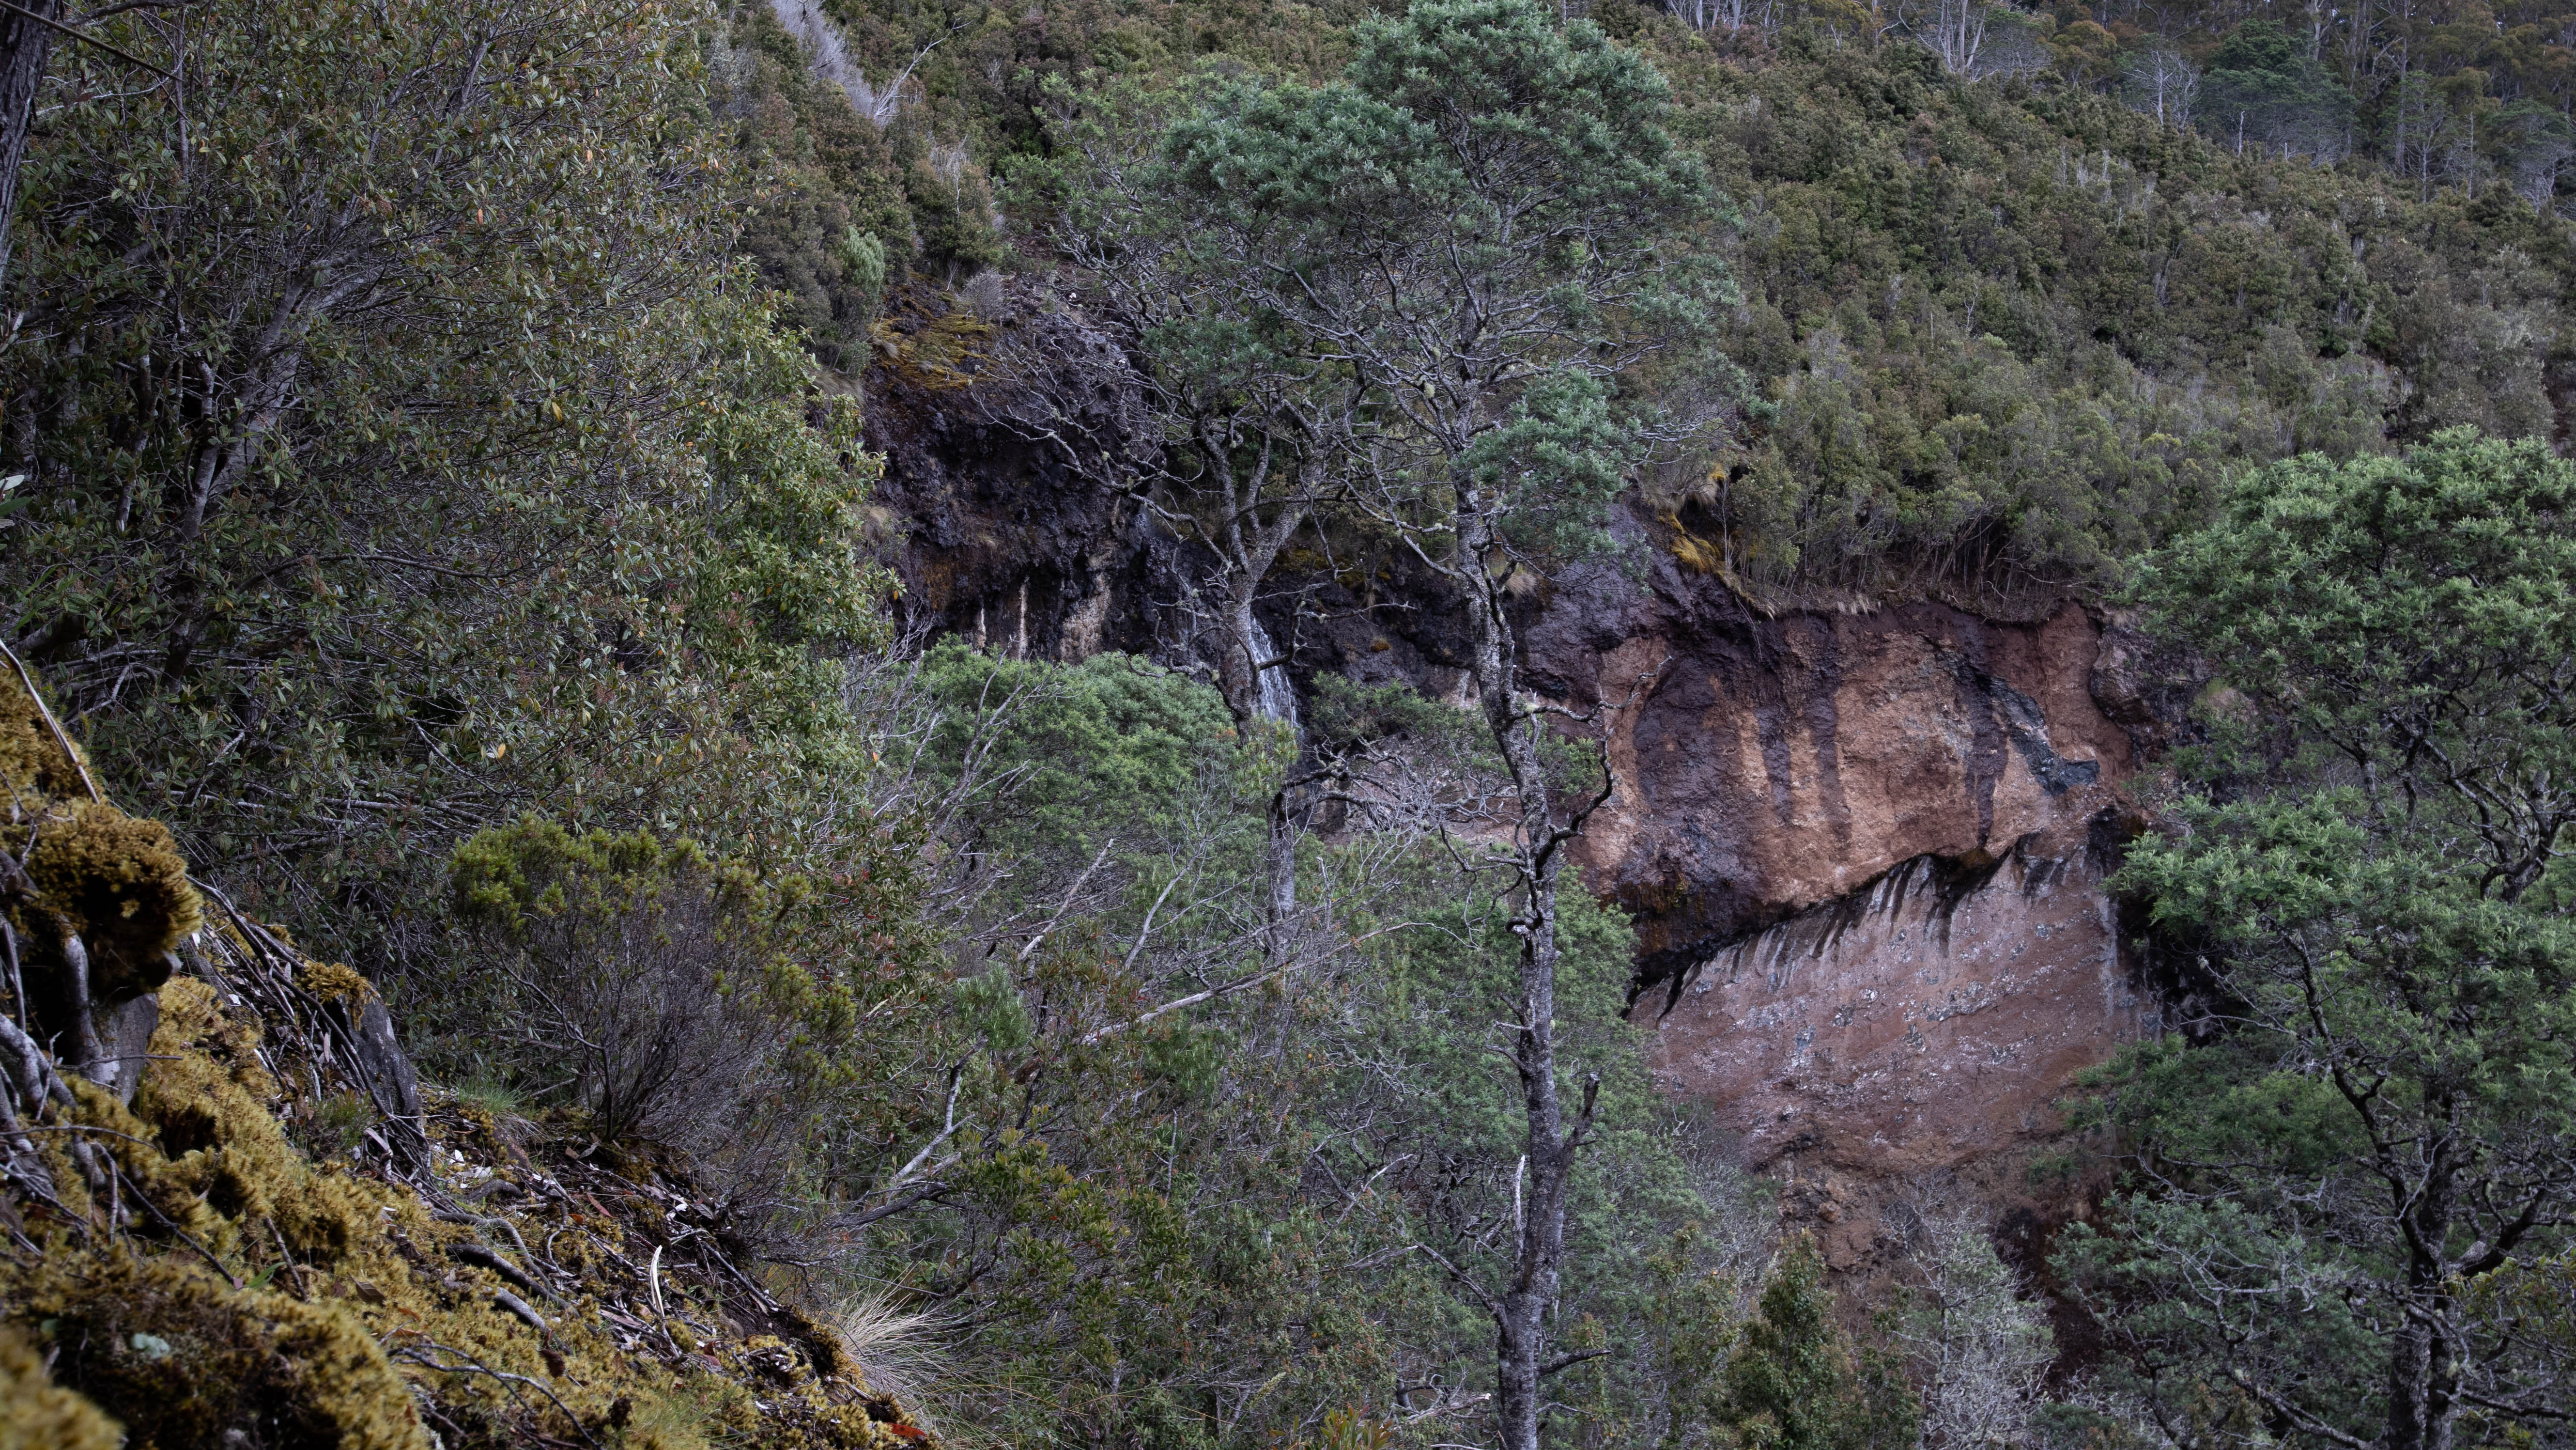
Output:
1164,0,1728,564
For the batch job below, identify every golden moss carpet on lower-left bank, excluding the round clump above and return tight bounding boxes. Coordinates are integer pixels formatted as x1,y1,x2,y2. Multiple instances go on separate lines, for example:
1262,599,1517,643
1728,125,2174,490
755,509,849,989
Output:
0,976,922,1450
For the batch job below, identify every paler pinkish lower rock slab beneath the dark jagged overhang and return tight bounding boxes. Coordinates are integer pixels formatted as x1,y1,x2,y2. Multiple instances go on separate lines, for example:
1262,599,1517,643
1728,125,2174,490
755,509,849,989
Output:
1636,791,2156,1177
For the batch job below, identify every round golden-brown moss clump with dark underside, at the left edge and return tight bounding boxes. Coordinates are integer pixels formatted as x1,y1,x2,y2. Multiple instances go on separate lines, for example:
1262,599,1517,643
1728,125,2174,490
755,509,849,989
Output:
26,801,206,994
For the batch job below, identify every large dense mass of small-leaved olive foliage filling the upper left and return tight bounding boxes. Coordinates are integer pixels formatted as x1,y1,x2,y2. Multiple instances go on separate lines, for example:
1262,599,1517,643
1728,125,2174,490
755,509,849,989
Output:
0,2,889,989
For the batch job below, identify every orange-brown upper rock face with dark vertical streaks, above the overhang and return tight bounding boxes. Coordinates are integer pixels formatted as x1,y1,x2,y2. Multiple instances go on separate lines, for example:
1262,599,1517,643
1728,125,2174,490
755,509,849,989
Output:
1530,561,2135,984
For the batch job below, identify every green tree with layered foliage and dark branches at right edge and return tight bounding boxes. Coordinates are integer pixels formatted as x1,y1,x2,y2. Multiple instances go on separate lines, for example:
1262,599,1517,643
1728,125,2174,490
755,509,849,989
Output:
2068,430,2576,1450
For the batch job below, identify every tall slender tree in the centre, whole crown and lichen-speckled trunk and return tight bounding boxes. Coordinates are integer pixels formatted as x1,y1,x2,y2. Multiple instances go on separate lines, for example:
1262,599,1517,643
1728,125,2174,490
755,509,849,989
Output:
1143,0,1721,1450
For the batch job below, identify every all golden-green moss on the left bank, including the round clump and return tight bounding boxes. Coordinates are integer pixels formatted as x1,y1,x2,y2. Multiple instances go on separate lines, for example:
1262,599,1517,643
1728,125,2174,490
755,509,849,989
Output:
0,667,942,1450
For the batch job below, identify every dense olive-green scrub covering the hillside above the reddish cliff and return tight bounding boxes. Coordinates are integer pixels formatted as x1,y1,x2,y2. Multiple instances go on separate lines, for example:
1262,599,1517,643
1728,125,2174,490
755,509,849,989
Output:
837,0,2576,608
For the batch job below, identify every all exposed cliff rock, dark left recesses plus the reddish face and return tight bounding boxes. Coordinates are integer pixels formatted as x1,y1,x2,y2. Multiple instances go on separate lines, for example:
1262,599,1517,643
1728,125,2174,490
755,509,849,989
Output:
871,335,2195,1221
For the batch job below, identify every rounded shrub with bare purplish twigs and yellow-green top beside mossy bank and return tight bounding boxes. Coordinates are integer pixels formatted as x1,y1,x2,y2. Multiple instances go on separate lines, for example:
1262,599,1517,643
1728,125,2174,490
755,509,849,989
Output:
441,816,871,1216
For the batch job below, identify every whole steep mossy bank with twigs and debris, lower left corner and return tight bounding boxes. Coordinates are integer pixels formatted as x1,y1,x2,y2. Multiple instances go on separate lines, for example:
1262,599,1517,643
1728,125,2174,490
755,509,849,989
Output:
0,672,930,1450
